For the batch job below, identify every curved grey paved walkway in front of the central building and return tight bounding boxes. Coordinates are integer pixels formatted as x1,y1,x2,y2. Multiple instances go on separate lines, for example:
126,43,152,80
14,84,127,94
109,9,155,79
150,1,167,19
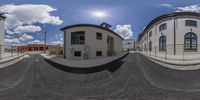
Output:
41,53,127,68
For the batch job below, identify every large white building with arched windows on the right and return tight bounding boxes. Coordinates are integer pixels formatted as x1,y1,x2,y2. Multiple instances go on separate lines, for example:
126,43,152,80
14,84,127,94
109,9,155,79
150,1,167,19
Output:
138,12,200,57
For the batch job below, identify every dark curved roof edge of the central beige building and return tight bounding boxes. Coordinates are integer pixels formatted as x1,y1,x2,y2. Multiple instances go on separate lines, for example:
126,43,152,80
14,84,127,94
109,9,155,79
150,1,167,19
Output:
60,24,124,40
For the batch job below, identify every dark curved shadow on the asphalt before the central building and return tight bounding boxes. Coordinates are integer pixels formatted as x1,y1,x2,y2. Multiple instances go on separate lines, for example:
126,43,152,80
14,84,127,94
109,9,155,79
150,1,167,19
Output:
45,54,128,74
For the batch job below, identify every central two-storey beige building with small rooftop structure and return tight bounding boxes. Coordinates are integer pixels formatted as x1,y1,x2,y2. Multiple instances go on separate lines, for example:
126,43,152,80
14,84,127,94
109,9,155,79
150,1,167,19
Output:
61,23,123,60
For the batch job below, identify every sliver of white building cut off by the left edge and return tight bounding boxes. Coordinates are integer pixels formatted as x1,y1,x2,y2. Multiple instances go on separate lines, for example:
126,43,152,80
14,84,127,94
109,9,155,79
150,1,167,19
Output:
0,14,6,45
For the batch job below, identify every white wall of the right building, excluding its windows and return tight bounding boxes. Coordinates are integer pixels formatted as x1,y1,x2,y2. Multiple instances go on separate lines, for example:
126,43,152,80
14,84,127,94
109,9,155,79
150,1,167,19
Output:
139,16,200,54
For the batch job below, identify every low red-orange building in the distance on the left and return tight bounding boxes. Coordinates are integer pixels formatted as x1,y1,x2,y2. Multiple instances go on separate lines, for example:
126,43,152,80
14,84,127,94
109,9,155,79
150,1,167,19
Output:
17,44,53,52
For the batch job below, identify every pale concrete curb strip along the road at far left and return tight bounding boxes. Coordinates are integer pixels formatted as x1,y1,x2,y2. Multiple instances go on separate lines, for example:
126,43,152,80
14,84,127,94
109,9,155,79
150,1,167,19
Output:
0,55,25,69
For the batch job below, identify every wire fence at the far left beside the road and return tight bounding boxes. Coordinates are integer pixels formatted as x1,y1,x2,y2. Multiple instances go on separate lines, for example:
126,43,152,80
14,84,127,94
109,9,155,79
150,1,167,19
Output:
0,45,21,60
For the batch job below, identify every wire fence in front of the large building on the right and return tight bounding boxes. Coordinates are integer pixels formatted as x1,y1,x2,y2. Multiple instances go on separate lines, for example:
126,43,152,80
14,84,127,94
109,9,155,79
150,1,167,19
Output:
142,44,200,62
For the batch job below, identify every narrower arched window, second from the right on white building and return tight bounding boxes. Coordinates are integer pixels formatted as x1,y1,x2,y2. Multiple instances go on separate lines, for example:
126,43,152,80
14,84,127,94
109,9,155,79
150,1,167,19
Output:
159,35,166,51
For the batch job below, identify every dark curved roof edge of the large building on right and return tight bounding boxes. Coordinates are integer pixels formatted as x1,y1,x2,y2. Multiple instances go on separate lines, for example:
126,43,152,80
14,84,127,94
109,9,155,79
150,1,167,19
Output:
138,12,200,40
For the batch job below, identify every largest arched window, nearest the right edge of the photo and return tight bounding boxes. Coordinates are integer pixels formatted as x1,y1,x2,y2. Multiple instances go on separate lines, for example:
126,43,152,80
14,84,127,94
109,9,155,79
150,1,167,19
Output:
184,32,197,50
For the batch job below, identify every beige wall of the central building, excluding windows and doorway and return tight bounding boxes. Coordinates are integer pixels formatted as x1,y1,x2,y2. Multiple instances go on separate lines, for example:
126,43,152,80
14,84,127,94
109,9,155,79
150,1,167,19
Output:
64,26,122,59
